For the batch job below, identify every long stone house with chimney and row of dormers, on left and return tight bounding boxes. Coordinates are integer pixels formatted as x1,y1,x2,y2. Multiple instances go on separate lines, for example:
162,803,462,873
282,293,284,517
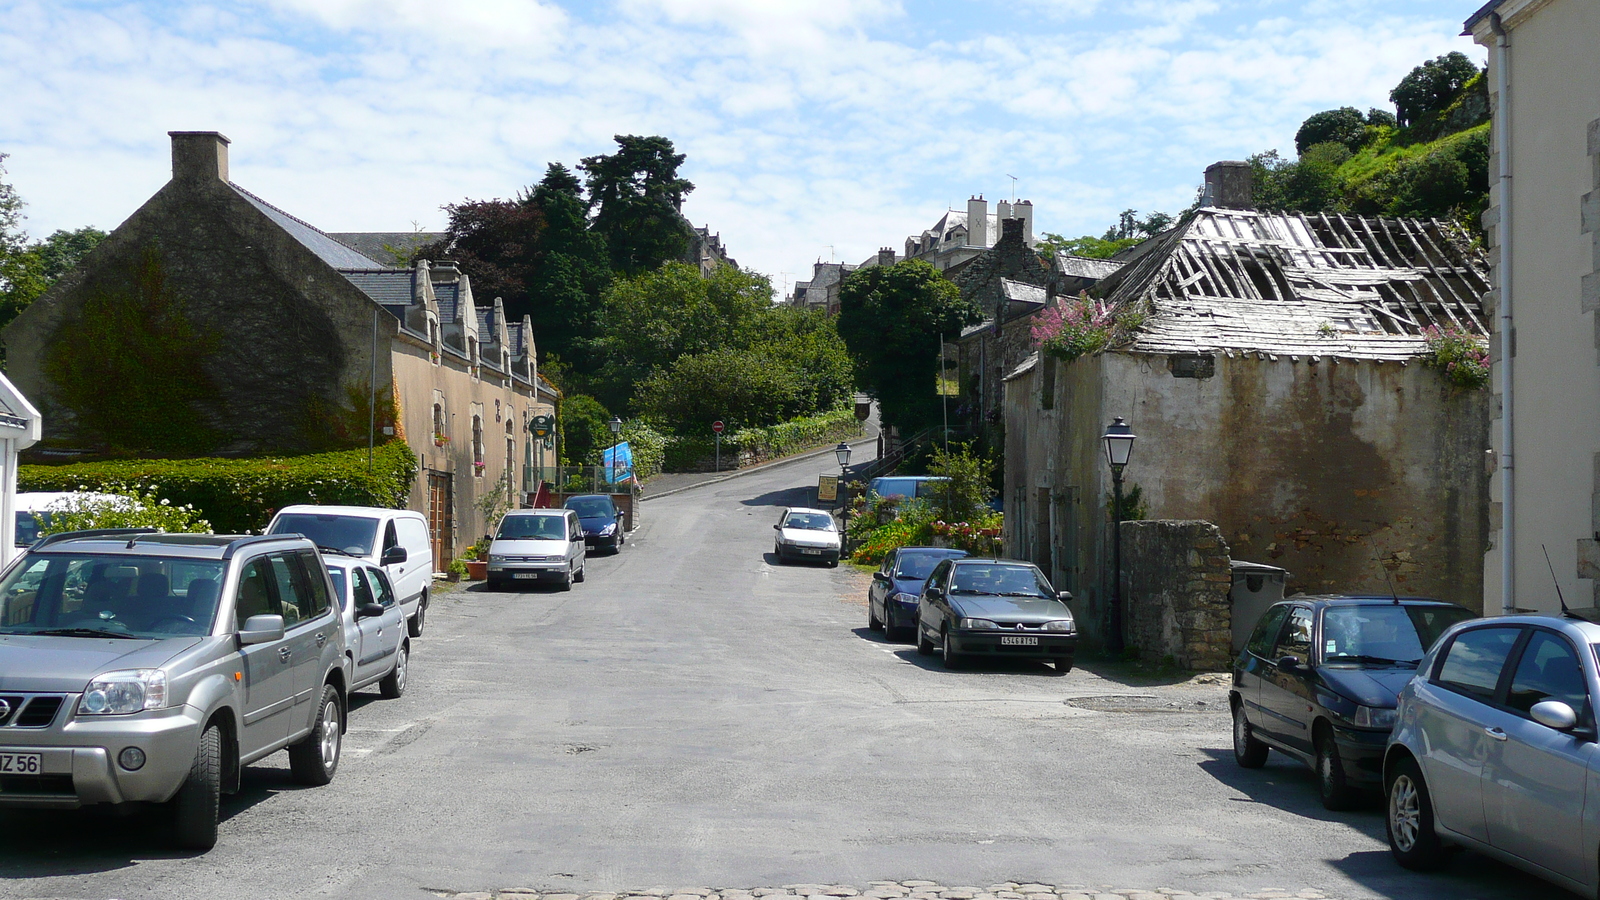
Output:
0,131,557,565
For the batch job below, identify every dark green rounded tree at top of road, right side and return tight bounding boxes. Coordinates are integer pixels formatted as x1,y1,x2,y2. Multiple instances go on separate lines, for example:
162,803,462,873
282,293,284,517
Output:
838,259,982,432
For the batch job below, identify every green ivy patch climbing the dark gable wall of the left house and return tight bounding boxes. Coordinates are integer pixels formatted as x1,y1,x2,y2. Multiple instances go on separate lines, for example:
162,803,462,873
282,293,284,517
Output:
43,247,222,456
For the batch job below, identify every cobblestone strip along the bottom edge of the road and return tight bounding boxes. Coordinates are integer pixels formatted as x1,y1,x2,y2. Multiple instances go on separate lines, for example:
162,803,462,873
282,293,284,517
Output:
432,881,1338,900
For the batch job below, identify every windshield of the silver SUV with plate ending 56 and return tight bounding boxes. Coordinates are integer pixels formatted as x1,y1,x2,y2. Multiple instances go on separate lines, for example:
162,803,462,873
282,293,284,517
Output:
0,552,226,639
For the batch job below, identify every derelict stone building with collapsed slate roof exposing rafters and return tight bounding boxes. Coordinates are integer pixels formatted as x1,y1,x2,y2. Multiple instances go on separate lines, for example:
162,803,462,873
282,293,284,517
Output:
1005,167,1490,643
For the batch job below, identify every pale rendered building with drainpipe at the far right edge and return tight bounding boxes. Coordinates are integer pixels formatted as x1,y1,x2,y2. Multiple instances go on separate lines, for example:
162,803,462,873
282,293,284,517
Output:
1466,0,1600,612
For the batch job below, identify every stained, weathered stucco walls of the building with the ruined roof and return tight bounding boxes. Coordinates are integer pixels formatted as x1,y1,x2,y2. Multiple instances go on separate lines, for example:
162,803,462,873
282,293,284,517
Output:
1006,354,1488,643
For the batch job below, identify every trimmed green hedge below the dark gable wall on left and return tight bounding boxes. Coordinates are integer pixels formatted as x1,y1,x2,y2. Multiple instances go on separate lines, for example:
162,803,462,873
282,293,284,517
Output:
18,440,416,535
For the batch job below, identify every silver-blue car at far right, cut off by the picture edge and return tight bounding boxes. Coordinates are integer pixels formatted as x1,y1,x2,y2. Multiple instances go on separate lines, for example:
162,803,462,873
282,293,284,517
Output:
1384,615,1600,897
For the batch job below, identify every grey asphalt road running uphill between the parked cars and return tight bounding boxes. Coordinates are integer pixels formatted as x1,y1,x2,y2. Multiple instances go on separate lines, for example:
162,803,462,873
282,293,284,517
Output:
0,458,1558,900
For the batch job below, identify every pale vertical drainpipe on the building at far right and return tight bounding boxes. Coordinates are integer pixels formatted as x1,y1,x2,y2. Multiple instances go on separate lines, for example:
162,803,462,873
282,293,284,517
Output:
1490,13,1517,615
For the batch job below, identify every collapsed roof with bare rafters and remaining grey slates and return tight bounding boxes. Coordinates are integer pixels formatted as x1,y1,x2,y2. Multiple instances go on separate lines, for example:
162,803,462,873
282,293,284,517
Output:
1094,208,1490,360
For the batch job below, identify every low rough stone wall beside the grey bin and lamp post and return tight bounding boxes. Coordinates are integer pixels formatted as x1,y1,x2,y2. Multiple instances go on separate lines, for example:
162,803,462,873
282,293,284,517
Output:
1122,519,1234,671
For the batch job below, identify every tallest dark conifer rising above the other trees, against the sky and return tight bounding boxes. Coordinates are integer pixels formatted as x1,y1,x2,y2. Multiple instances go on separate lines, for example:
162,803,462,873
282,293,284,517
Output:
578,135,694,275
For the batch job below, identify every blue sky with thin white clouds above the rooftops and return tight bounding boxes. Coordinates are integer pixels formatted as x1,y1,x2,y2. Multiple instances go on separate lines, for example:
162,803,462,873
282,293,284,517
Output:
0,0,1483,297
